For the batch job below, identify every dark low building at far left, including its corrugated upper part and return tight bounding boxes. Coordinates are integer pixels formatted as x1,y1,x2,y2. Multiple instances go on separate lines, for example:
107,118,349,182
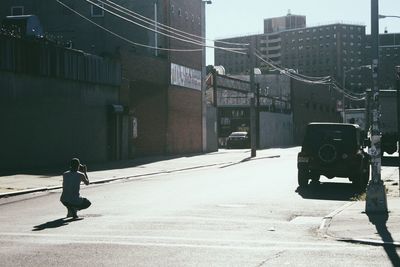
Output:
0,34,122,173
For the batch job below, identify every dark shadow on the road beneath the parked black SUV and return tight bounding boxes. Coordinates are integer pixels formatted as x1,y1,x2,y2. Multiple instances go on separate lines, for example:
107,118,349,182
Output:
296,183,362,201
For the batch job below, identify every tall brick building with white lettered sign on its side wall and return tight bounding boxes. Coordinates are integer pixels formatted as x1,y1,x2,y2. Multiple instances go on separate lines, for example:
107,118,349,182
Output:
0,0,209,158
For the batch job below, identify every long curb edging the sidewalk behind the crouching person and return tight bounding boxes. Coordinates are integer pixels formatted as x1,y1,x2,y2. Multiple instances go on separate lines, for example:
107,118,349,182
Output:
0,155,280,199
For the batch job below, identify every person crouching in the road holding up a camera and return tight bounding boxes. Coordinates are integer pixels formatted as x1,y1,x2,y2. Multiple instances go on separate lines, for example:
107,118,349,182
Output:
60,158,92,219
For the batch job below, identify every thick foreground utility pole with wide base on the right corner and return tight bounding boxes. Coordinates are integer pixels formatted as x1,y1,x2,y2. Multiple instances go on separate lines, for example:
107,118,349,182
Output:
365,0,388,213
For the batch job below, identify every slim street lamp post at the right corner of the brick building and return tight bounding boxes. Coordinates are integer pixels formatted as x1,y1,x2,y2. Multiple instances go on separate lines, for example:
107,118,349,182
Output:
200,0,212,152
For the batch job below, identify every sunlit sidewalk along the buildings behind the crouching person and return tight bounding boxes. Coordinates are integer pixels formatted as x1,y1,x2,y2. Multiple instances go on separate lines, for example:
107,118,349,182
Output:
0,149,281,198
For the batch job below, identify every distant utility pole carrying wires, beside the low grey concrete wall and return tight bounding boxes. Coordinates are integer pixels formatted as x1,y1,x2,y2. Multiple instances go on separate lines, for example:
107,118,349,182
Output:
249,38,257,158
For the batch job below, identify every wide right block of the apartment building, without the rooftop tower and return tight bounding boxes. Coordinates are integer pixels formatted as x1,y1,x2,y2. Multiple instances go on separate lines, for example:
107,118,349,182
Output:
281,23,367,94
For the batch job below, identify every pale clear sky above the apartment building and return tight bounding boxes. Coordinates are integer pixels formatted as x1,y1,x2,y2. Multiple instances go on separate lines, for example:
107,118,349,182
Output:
206,0,400,65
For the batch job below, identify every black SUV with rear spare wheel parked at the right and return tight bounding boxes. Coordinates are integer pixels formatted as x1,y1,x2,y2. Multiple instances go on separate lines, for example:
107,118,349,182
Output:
297,123,370,190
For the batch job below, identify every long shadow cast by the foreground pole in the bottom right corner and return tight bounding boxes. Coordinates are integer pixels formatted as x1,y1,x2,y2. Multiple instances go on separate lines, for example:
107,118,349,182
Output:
367,213,400,266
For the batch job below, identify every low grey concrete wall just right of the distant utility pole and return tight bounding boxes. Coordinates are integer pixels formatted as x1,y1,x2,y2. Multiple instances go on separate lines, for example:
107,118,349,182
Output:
259,112,293,149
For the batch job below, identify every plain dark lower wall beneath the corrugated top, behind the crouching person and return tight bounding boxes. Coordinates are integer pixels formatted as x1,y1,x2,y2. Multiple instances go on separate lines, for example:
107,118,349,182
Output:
0,71,118,171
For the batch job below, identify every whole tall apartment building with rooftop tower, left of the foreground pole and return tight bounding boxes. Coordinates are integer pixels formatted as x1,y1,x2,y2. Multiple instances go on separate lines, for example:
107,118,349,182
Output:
215,14,369,94
